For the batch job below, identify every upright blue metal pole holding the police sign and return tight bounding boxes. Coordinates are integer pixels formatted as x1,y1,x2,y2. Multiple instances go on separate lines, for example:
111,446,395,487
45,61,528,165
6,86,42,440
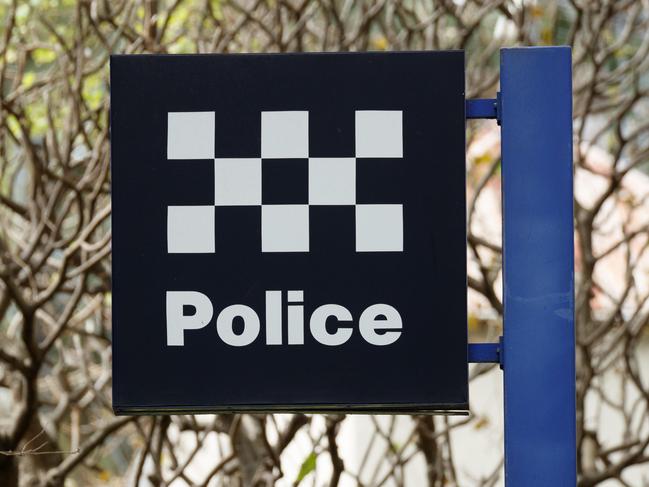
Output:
499,47,576,487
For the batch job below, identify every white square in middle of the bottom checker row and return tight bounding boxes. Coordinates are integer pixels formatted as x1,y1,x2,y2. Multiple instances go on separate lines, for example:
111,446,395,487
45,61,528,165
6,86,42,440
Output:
261,205,309,252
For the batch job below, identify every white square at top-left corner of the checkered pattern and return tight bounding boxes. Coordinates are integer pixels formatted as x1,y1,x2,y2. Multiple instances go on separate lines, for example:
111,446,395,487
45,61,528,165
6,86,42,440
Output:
167,112,214,159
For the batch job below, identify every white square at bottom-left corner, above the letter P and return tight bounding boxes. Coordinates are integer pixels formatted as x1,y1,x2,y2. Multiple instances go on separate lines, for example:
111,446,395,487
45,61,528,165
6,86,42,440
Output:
167,205,215,254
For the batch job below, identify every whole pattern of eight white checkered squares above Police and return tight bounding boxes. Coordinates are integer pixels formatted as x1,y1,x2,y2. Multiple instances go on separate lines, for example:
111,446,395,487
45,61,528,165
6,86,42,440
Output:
167,110,403,253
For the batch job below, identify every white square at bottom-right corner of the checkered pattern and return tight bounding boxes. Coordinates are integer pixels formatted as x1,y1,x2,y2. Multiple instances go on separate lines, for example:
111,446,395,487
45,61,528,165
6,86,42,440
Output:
356,205,403,252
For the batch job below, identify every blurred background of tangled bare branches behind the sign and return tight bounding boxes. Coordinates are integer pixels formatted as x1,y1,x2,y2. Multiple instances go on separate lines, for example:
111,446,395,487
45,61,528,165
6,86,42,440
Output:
0,0,649,487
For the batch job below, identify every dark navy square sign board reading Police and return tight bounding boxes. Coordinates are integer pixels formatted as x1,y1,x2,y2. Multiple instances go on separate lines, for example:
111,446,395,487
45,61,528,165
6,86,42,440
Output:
111,52,468,414
